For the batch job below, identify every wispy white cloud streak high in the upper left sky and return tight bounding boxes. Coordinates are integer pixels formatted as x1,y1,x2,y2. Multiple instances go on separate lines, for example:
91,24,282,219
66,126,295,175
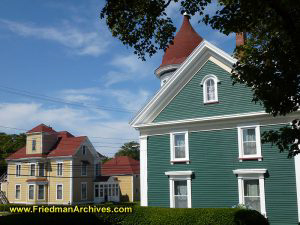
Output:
0,19,109,56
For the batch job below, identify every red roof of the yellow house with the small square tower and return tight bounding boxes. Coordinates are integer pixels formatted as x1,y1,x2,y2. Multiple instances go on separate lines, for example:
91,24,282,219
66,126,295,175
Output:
6,124,87,160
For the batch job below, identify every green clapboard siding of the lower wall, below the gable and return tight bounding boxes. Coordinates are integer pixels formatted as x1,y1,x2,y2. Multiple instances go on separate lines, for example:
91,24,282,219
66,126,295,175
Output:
148,126,298,225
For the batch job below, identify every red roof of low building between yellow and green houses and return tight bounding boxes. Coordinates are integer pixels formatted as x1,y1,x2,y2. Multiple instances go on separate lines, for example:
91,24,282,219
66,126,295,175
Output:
101,156,140,176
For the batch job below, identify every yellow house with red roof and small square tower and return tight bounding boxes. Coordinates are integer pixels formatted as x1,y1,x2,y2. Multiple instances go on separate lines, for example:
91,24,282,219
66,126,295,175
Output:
0,124,102,204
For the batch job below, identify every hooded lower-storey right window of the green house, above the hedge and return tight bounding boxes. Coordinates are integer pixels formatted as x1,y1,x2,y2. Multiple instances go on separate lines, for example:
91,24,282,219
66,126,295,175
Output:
233,169,267,216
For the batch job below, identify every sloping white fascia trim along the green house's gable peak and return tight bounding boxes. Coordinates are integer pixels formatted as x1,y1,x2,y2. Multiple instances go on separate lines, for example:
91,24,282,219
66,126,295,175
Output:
129,41,237,128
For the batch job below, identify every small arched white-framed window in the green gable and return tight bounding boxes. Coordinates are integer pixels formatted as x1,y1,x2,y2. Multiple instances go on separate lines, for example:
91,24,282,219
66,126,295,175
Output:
201,75,219,103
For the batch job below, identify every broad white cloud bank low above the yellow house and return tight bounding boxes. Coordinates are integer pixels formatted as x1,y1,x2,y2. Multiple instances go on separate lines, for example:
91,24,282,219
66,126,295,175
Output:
0,103,138,156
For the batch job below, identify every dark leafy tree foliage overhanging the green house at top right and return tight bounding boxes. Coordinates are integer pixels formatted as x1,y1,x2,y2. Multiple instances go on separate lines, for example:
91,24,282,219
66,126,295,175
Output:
100,0,300,157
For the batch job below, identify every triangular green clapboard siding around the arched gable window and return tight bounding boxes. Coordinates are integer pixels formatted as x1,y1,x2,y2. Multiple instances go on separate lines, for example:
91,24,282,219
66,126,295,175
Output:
154,61,264,122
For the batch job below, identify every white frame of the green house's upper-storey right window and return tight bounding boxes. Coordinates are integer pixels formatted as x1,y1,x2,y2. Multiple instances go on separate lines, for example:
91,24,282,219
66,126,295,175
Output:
237,124,262,162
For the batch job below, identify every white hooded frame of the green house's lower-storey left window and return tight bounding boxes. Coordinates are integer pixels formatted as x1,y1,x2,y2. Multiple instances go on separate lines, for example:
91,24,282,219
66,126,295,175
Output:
165,171,193,208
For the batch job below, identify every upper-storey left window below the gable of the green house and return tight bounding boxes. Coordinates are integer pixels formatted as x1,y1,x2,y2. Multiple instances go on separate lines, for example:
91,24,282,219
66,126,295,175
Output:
170,131,189,163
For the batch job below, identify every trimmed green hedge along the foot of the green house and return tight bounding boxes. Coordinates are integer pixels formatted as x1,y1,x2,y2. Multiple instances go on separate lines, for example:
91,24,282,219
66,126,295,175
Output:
98,207,269,225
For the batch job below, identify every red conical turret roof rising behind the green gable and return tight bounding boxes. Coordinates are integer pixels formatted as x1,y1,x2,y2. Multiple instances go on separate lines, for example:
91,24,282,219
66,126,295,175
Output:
160,15,203,67
